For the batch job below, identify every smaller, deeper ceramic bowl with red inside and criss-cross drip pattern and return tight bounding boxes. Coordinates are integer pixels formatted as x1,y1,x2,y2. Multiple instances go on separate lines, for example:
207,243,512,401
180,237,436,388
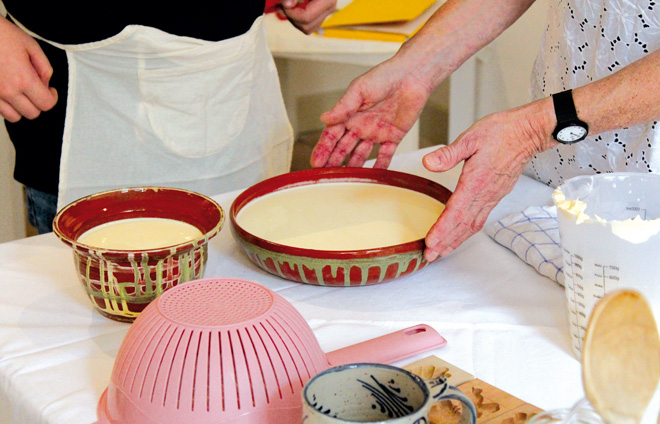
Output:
53,187,224,322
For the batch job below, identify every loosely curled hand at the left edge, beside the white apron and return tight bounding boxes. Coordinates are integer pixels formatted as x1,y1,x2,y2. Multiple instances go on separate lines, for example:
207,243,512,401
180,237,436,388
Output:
0,16,57,122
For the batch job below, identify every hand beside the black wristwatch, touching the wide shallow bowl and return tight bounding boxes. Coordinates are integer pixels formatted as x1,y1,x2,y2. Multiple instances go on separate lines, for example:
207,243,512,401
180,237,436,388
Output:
423,99,557,261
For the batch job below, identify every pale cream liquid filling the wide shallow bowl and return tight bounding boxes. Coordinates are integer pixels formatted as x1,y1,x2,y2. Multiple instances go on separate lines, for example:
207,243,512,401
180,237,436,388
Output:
236,182,444,250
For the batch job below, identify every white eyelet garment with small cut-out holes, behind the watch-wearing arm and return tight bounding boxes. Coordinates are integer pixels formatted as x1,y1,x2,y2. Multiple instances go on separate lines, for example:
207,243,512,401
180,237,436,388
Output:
525,0,660,187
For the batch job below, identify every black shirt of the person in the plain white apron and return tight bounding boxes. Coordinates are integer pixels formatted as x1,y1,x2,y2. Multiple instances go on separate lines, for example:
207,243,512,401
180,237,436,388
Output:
3,0,265,194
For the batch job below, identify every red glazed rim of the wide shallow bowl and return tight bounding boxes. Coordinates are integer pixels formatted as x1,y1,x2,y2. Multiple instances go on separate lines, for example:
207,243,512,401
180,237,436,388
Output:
229,168,452,260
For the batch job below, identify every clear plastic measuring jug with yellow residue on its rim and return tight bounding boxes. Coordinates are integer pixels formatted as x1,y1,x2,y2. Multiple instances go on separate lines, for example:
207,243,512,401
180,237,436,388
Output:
552,173,660,358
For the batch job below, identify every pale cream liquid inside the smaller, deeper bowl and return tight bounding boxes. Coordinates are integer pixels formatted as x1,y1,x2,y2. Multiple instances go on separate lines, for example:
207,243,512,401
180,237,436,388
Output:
77,218,202,250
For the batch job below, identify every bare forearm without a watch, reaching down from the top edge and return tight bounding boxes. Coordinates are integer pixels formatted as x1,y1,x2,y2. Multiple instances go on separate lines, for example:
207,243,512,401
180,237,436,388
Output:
396,0,535,87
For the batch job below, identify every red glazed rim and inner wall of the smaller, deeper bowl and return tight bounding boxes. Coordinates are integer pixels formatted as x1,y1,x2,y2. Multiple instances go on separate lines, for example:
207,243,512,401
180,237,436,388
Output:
53,186,225,258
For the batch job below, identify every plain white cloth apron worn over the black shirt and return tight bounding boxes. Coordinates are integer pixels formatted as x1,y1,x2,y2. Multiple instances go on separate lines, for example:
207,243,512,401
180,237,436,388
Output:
11,17,293,209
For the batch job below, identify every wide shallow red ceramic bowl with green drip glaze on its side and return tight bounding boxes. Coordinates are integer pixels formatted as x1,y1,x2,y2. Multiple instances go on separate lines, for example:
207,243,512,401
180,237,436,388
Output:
229,168,451,286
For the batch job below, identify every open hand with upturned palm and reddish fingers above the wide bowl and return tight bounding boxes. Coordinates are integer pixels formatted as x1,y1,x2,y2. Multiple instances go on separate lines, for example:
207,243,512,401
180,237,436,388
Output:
310,59,433,168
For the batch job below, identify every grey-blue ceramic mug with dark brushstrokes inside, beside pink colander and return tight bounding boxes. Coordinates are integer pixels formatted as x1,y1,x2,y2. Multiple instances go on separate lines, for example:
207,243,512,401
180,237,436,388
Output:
302,363,477,424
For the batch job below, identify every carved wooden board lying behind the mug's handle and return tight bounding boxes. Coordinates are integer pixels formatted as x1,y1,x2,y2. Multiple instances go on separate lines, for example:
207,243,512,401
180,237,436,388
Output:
403,356,543,424
